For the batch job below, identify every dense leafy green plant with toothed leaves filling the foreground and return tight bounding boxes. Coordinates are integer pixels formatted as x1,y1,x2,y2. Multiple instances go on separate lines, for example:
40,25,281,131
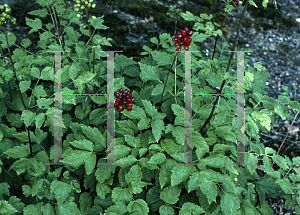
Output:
0,0,300,215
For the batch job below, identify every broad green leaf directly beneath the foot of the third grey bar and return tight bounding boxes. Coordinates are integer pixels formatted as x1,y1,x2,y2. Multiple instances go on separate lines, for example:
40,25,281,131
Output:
171,165,196,186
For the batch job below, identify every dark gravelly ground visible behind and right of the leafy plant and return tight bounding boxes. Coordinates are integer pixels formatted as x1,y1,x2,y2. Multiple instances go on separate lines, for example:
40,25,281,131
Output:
0,0,300,215
